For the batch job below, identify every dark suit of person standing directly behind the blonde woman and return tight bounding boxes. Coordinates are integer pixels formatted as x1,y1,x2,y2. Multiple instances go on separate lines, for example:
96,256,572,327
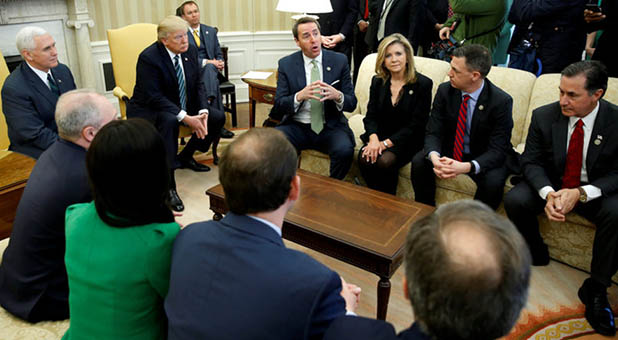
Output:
365,0,427,52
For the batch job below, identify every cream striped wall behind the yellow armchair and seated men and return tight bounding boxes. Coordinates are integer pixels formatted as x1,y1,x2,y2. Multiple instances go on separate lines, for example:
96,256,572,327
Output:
88,0,292,41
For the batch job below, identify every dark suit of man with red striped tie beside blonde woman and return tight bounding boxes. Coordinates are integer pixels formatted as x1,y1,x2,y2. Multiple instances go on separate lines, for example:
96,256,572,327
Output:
411,79,513,209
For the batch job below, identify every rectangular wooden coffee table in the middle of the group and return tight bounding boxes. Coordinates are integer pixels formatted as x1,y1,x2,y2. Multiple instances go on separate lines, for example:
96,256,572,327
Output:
206,170,434,320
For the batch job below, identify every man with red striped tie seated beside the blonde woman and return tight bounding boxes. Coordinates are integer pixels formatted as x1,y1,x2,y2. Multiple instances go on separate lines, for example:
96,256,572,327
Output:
411,44,513,209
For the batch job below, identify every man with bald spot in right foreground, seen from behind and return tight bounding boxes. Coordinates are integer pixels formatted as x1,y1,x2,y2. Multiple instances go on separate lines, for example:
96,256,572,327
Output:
324,200,531,340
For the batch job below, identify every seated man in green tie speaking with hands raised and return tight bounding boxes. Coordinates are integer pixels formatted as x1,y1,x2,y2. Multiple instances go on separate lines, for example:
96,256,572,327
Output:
271,17,356,179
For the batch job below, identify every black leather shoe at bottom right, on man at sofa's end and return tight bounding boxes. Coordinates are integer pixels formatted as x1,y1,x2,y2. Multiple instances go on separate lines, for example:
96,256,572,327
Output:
577,282,616,336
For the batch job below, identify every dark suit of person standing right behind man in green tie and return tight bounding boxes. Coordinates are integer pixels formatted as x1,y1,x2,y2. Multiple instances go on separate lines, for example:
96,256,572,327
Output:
318,0,358,65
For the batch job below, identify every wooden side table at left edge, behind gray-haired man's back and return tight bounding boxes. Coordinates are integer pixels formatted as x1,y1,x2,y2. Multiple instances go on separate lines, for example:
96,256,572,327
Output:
0,151,36,240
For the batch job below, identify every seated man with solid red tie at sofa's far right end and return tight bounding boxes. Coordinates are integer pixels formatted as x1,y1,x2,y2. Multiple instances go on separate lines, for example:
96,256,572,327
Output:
504,61,618,335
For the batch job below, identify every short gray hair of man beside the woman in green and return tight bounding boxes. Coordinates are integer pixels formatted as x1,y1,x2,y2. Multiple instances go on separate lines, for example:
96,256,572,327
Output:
56,89,107,141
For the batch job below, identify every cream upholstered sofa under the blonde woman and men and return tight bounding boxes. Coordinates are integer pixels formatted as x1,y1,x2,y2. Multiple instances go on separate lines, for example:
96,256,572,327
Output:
300,54,618,282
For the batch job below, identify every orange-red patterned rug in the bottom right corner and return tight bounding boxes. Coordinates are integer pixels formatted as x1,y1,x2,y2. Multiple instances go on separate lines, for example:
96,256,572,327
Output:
503,304,618,340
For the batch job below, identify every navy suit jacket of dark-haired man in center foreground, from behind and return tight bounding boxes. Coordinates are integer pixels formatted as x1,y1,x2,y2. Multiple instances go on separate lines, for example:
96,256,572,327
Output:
165,213,345,340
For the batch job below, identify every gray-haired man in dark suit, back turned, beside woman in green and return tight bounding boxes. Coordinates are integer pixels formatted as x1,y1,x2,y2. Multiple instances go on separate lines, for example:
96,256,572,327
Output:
0,90,117,322
